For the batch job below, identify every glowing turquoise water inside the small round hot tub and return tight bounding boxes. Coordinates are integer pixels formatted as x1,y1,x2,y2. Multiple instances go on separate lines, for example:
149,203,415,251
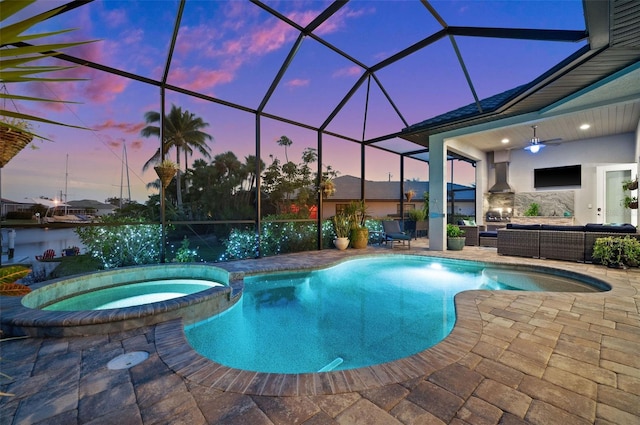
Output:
43,279,223,311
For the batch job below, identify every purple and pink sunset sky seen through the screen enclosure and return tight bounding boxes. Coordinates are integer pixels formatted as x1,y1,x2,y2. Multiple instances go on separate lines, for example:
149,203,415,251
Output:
2,0,585,202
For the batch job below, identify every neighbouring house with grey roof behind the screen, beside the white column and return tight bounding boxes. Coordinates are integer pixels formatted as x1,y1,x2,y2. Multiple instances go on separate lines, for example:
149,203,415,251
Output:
322,175,476,218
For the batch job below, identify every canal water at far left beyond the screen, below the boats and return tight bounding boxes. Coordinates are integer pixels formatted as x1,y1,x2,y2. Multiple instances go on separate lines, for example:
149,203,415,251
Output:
1,227,85,265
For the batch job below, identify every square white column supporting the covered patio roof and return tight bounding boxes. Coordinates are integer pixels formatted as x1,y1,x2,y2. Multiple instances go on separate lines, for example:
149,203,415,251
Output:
429,135,447,251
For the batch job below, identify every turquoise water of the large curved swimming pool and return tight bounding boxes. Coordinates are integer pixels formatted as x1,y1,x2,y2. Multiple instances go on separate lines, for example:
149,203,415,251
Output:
185,256,608,373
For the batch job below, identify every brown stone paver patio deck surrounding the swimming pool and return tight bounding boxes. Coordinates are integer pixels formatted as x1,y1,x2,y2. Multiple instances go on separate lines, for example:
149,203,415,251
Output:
0,239,640,425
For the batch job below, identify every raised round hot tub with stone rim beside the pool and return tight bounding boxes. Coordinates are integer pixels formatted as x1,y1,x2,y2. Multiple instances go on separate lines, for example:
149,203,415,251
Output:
0,264,241,336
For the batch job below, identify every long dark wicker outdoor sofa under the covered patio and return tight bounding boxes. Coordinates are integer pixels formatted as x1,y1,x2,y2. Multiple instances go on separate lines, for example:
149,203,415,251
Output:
498,223,640,262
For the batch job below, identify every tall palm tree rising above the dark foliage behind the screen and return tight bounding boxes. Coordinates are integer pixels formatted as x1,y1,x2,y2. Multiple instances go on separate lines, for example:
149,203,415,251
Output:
140,105,213,209
